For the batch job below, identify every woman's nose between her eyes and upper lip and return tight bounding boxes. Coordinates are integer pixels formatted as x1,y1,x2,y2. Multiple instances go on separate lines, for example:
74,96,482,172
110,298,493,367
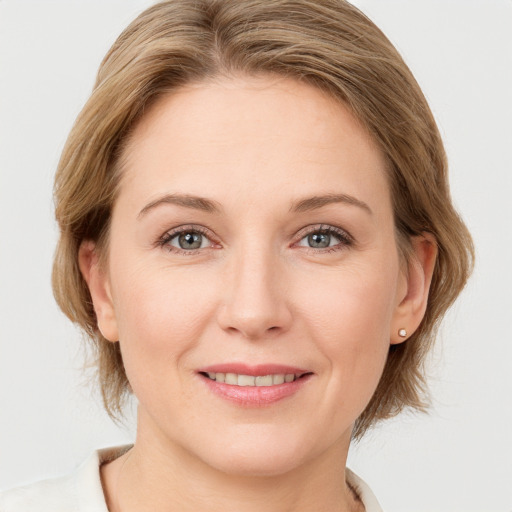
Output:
218,247,292,340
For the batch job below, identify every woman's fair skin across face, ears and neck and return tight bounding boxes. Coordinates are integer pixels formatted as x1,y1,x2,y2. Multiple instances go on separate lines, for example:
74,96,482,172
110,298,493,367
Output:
79,77,435,512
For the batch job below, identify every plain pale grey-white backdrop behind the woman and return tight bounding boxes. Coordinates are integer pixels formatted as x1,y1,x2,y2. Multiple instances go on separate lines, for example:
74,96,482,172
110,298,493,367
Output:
0,0,512,512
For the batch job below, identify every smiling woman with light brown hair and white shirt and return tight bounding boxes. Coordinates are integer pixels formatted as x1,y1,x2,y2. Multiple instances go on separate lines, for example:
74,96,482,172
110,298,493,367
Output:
0,0,472,512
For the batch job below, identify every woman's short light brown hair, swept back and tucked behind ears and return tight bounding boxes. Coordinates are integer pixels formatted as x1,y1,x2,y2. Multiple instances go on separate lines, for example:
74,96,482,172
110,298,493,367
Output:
53,0,473,437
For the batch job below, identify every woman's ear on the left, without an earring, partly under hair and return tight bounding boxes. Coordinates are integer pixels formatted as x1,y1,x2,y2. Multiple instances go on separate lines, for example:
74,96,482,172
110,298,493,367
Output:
78,240,119,342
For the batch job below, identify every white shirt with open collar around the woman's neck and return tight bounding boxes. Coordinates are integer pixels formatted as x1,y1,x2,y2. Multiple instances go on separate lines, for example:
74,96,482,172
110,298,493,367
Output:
0,446,382,512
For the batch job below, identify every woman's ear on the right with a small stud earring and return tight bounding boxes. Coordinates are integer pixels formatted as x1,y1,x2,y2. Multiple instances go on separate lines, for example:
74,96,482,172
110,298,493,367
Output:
390,233,437,345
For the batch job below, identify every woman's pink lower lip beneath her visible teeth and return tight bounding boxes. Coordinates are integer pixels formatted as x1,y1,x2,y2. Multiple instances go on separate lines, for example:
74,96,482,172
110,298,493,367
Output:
200,375,312,407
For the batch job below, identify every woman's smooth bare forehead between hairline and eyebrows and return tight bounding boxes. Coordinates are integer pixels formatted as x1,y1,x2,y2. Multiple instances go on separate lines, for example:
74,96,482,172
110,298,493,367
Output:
121,76,389,217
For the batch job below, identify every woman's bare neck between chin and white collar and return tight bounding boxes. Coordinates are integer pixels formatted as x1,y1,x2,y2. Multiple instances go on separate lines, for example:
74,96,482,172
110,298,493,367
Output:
102,420,364,512
